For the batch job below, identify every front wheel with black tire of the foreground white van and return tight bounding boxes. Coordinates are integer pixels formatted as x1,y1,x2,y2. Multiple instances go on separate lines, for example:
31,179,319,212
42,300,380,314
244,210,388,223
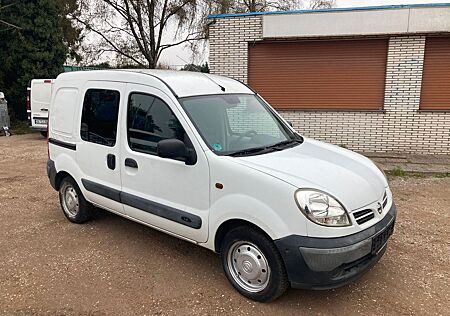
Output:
220,226,289,302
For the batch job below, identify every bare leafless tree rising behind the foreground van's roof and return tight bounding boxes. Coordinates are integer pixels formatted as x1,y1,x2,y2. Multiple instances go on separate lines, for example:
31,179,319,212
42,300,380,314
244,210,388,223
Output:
72,0,204,68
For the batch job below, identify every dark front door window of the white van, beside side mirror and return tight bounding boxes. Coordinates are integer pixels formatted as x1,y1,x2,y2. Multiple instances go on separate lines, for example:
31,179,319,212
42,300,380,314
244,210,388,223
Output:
127,93,185,155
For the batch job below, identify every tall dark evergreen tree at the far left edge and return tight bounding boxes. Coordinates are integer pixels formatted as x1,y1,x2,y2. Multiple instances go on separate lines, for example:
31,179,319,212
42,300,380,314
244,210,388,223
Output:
0,0,70,119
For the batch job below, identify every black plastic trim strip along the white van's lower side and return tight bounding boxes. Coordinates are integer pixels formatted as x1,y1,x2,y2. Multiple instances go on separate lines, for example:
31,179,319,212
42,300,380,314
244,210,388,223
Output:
81,179,202,229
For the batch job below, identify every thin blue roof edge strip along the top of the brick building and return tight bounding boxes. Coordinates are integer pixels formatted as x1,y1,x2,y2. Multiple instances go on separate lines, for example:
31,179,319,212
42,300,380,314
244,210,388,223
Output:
208,3,450,19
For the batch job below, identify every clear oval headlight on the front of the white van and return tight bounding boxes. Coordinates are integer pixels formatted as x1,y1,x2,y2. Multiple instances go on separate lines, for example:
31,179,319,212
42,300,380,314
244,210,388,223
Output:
295,189,351,226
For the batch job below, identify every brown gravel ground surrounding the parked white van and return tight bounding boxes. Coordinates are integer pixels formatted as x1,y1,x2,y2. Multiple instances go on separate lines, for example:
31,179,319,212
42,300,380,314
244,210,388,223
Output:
0,134,450,315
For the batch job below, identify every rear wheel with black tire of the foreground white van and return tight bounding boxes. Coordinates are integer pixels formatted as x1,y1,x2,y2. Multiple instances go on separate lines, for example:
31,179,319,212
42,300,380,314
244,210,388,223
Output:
59,177,93,224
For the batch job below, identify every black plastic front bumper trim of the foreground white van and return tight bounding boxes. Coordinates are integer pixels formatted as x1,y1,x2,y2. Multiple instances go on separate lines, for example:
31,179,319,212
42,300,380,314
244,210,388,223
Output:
275,204,397,289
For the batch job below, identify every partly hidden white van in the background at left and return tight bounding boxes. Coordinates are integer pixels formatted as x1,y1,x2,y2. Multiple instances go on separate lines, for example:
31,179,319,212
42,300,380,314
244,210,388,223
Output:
27,79,54,136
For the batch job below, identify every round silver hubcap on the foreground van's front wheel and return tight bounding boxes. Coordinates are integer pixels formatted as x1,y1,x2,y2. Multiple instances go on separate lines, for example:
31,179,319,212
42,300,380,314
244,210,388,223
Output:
227,241,270,293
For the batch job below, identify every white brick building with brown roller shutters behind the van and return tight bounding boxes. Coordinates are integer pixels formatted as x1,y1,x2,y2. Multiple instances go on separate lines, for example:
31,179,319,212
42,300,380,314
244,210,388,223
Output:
209,4,450,154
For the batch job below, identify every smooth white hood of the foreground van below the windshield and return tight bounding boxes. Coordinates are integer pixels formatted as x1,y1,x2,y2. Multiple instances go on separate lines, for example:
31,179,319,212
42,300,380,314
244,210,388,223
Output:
235,138,388,211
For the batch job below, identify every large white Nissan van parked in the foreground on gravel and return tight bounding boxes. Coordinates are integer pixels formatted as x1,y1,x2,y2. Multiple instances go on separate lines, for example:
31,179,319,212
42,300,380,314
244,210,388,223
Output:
47,70,396,301
